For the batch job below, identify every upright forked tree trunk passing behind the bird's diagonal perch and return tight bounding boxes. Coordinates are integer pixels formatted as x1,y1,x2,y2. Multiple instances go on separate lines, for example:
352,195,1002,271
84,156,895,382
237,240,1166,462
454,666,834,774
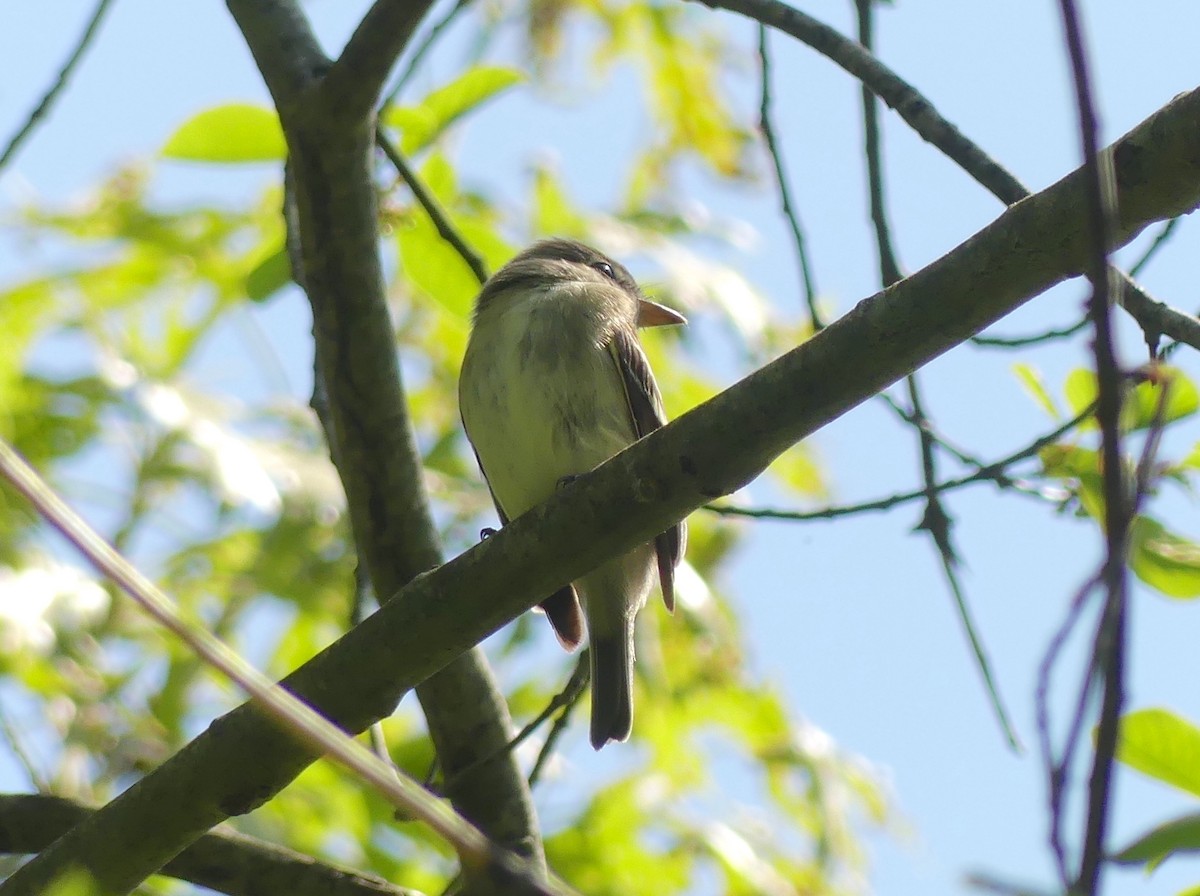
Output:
242,0,544,892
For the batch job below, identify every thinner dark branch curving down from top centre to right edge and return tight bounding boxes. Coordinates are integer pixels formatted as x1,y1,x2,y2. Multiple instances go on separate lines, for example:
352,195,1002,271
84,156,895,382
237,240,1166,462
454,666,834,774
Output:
700,0,1200,350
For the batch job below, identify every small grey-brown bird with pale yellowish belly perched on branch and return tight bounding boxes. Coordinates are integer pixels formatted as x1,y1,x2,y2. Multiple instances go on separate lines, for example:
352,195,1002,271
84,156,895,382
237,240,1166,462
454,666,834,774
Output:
458,239,688,750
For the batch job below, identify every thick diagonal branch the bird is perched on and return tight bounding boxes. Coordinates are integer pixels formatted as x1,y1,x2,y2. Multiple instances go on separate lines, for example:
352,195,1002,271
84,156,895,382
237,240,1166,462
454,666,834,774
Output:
0,90,1200,896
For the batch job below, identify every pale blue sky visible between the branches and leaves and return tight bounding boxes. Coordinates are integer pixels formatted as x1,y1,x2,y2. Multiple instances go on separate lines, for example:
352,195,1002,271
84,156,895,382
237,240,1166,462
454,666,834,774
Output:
0,0,1200,896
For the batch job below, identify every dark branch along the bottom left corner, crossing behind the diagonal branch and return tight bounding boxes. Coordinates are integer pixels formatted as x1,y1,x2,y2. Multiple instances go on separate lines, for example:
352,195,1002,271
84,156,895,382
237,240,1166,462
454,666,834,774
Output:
0,794,415,896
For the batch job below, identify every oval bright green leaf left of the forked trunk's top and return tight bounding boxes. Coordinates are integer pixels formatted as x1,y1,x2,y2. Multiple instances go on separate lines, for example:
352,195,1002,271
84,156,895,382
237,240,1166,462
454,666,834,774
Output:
162,103,287,164
